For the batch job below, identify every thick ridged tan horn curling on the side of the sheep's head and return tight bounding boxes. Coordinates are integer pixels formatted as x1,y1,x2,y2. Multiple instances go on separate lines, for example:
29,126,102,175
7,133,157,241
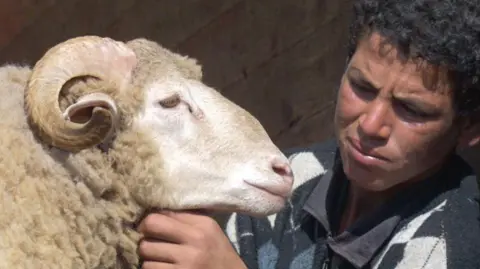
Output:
25,36,136,152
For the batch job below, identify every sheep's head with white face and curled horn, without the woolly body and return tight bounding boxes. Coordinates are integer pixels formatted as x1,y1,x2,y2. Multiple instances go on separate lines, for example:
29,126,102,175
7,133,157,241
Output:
25,36,293,215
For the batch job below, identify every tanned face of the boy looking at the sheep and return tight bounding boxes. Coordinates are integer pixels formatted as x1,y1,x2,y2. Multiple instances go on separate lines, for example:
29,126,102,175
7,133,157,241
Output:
335,33,478,191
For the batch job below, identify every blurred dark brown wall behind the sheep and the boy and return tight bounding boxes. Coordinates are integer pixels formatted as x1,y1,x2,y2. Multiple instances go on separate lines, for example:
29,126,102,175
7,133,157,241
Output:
0,0,480,172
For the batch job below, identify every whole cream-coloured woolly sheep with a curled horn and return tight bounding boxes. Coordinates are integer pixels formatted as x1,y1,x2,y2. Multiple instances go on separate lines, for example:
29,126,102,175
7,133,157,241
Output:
0,36,293,269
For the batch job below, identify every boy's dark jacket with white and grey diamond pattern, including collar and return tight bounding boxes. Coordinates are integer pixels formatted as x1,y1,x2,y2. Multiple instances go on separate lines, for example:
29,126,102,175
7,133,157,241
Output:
227,141,480,269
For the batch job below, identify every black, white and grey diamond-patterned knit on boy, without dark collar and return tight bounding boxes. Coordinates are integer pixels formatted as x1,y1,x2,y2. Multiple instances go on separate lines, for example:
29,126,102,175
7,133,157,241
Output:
226,141,480,269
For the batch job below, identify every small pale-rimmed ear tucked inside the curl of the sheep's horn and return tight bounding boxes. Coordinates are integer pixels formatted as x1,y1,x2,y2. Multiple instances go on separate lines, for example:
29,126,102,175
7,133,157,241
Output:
63,93,118,123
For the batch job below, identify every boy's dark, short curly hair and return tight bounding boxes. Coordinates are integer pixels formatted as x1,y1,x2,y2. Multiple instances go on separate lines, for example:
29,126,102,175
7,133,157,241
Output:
348,0,480,122
